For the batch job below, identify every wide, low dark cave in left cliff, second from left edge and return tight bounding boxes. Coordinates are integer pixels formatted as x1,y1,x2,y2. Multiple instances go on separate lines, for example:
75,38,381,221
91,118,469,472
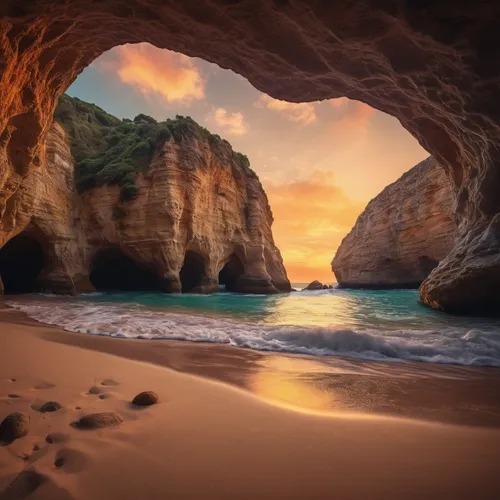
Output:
90,249,159,291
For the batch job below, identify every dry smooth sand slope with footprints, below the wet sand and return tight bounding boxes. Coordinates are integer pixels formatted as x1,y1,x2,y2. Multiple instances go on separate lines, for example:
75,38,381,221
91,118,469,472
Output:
0,311,500,500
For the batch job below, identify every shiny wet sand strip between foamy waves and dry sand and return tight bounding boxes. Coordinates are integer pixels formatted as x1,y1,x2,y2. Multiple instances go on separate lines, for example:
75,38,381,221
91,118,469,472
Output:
0,306,500,428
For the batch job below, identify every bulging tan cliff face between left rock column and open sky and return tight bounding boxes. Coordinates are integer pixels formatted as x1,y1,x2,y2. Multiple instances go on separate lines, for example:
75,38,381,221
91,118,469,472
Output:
81,127,290,293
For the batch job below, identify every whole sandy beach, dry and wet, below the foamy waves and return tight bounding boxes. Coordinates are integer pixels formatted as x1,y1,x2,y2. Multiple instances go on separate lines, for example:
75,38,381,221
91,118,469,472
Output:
0,307,500,500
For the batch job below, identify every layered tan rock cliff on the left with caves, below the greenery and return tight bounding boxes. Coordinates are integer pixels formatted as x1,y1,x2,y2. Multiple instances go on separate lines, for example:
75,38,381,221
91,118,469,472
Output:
0,96,290,293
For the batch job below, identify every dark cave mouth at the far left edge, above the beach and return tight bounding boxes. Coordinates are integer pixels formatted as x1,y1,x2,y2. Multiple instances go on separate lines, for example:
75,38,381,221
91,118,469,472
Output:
0,231,45,294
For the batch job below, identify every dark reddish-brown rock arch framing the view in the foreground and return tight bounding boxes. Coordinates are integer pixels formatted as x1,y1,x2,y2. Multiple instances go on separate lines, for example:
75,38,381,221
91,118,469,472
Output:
0,0,500,312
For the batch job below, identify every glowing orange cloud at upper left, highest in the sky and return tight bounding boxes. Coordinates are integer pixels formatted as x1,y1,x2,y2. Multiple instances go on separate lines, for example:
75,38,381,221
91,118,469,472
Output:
96,43,205,104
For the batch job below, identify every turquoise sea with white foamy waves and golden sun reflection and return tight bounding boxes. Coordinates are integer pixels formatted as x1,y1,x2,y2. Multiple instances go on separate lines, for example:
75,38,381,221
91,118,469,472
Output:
7,289,500,366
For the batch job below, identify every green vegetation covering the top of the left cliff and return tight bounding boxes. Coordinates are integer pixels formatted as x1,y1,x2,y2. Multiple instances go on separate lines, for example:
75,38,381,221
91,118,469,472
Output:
54,94,251,201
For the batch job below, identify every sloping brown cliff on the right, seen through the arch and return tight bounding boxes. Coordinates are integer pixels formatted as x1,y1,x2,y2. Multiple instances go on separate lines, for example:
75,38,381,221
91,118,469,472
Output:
332,157,456,288
